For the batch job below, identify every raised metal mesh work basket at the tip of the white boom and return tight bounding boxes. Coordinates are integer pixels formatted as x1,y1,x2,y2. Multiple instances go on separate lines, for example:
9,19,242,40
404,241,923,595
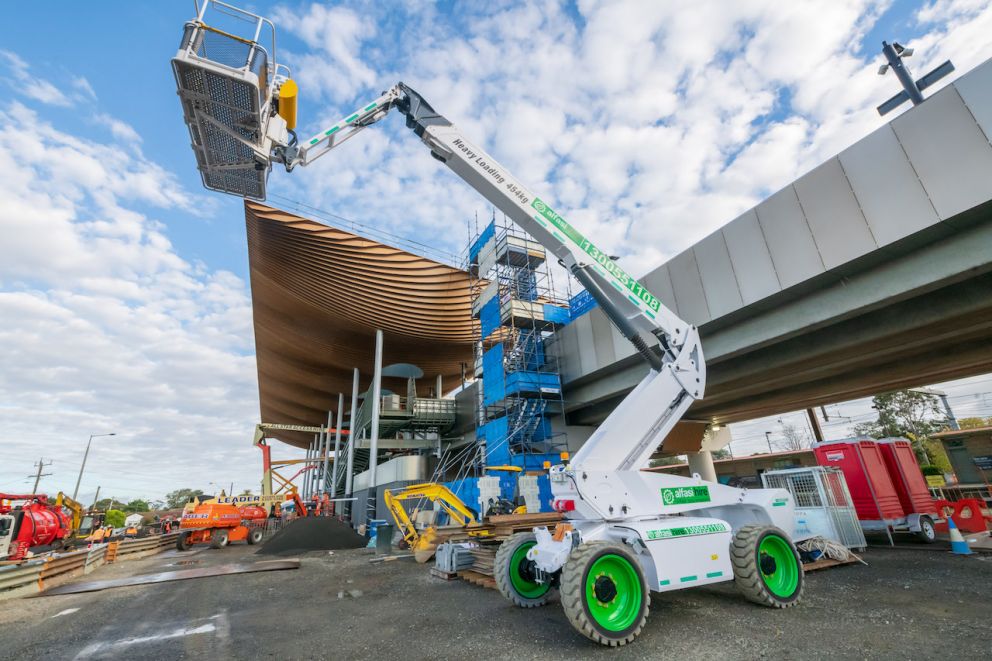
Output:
172,0,289,200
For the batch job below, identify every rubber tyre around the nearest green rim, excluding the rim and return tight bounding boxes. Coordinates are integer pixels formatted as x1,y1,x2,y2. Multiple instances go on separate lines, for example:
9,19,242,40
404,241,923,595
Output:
561,541,651,647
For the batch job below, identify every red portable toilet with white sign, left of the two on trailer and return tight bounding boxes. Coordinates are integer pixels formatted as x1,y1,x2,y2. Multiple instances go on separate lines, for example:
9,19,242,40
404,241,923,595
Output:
813,438,906,529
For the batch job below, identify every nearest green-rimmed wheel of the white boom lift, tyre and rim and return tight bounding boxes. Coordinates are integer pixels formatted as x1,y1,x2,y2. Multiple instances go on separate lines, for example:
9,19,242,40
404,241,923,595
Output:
561,541,651,647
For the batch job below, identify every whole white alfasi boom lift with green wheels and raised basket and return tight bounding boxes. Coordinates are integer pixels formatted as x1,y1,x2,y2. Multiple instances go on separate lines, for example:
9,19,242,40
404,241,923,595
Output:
173,0,803,646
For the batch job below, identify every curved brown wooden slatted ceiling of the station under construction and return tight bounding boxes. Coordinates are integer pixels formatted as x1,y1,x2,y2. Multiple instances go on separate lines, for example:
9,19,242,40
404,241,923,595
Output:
245,201,476,447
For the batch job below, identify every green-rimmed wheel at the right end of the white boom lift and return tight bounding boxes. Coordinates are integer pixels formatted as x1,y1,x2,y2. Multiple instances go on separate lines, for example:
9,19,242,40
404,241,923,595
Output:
730,526,803,608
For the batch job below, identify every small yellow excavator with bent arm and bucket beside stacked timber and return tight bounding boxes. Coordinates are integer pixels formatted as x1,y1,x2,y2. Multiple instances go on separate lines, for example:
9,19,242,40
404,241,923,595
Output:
383,466,527,564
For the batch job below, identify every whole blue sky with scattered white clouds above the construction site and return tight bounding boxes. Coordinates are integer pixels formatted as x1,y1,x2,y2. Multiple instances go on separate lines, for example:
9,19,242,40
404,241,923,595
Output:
0,0,992,497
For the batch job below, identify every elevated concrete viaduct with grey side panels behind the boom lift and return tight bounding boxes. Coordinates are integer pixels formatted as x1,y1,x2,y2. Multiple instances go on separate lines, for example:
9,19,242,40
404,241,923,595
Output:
552,56,992,425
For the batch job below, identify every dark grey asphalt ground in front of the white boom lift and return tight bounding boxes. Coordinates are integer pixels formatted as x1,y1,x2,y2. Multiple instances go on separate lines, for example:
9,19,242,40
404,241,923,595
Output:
0,545,992,661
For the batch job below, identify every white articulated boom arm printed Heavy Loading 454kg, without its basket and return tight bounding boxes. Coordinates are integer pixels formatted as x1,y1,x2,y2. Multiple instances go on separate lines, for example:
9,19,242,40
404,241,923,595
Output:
273,83,706,470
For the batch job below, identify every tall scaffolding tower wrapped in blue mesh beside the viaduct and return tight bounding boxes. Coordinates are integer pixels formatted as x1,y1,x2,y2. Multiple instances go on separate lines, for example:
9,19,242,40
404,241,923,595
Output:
440,217,570,502
